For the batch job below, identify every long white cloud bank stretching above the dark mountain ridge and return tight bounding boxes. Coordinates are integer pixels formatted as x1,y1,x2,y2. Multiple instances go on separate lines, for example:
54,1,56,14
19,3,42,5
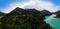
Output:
1,0,57,13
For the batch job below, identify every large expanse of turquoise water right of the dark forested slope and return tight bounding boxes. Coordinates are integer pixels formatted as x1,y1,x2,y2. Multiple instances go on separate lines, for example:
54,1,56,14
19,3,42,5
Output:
44,15,60,29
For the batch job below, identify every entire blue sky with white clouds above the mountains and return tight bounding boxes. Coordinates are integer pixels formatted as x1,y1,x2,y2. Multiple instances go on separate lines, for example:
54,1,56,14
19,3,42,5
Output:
0,0,60,13
